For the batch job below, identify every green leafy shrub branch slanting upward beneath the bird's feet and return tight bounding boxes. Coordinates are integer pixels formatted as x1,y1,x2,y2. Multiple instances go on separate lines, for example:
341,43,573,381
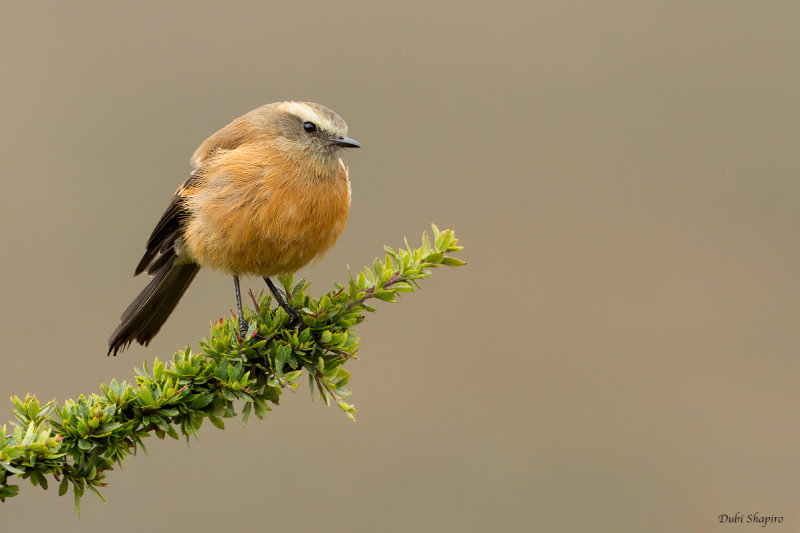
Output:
0,225,465,513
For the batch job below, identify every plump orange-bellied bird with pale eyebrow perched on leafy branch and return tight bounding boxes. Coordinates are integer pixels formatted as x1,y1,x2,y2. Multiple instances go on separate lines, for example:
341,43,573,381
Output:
108,102,360,355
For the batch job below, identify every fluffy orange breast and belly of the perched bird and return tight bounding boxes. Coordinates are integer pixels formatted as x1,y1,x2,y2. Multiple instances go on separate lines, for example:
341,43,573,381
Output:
184,149,350,276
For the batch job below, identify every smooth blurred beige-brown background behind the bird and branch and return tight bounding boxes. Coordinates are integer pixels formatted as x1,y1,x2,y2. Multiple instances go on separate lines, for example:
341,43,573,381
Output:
0,0,800,532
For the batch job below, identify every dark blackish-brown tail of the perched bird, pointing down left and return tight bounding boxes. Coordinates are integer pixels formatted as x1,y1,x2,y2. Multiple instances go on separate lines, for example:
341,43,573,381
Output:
108,255,200,355
